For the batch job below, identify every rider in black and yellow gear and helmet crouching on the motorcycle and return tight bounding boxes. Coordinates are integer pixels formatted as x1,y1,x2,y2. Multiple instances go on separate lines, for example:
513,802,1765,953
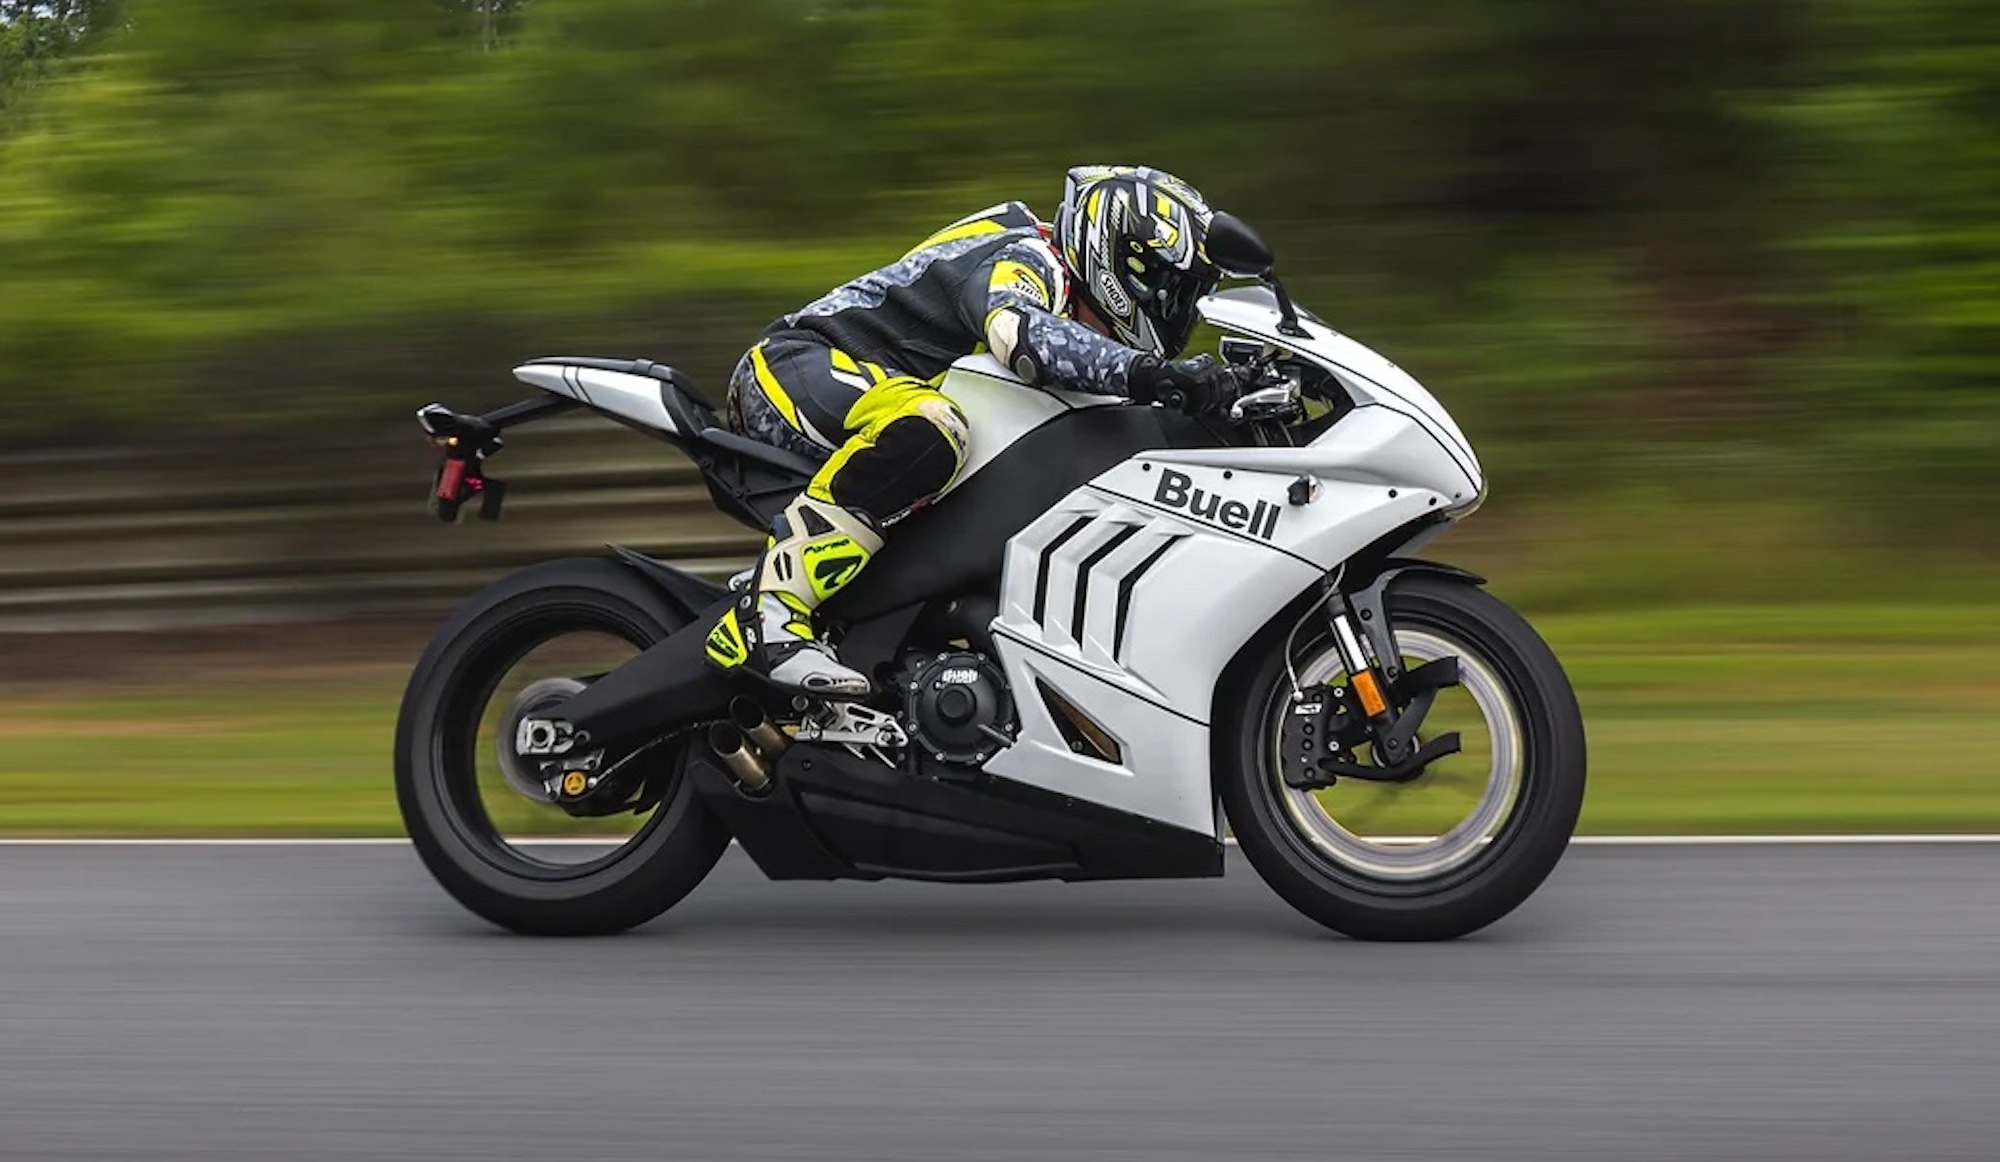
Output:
708,166,1234,696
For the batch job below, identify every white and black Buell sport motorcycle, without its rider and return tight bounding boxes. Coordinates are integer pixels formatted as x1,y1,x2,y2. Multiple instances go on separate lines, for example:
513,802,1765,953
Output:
396,214,1586,940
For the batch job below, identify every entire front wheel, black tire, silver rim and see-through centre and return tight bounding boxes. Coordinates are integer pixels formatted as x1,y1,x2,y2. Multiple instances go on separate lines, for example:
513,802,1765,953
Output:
1218,574,1586,940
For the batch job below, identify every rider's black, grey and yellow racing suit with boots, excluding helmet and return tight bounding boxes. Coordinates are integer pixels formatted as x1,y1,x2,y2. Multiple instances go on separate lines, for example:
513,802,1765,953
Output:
708,202,1138,696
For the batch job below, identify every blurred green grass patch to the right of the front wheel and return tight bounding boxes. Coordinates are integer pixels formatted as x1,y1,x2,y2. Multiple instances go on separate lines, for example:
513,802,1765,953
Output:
1544,606,2000,832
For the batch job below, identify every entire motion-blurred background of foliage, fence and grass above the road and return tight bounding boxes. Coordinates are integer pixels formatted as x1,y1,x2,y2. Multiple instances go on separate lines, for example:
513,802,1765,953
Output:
0,0,2000,834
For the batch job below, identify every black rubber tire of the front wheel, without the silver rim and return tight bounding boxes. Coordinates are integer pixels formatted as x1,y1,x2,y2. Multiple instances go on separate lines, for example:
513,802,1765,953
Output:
1218,574,1586,940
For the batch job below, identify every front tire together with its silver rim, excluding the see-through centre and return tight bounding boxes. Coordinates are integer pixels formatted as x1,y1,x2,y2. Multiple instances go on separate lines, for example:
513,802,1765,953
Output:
1218,574,1586,940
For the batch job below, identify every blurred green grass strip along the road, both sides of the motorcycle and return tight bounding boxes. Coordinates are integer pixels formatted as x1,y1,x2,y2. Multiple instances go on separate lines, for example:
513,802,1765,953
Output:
0,604,2000,836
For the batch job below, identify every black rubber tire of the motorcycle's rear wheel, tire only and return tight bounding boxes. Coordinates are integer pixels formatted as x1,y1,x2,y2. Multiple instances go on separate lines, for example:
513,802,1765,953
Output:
396,560,728,936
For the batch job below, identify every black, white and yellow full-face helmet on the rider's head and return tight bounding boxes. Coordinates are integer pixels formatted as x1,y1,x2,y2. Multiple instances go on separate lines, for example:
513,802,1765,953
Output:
1056,166,1220,358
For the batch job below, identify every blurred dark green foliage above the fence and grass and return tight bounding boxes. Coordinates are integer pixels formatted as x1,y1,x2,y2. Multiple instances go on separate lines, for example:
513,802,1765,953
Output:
0,0,2000,542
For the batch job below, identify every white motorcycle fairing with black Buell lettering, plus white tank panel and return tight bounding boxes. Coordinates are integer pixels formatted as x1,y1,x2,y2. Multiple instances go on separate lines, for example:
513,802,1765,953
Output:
944,290,1484,834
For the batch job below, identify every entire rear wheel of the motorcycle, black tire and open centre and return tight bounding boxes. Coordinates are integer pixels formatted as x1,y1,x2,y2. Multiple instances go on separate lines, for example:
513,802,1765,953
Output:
396,560,728,936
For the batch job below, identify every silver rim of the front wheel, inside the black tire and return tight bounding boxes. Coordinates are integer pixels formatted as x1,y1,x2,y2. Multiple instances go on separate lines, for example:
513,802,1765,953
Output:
1264,626,1526,880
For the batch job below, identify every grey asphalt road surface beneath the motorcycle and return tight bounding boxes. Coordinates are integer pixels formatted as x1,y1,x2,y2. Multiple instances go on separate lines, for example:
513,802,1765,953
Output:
0,846,2000,1162
